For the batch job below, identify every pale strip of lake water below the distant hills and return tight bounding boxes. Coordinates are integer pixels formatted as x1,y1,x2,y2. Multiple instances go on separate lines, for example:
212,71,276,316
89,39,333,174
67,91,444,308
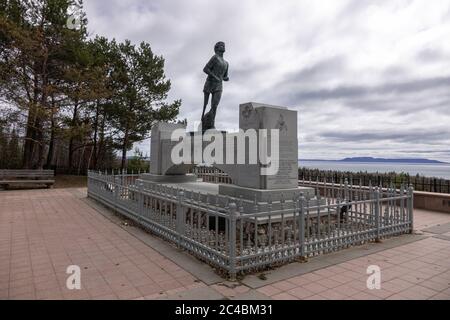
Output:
299,160,450,179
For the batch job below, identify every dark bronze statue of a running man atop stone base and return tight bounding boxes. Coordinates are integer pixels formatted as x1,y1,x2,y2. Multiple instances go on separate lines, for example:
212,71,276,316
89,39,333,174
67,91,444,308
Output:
202,42,229,132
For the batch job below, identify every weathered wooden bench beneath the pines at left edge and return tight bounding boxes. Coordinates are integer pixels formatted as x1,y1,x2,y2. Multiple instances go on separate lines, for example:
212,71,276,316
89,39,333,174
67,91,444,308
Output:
0,170,55,189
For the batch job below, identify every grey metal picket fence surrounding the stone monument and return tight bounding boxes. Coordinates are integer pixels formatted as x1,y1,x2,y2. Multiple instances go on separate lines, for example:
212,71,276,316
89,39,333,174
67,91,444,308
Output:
88,172,413,278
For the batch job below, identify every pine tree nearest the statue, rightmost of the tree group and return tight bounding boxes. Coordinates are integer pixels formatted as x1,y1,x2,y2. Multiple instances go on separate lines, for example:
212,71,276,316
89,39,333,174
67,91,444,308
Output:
111,40,181,169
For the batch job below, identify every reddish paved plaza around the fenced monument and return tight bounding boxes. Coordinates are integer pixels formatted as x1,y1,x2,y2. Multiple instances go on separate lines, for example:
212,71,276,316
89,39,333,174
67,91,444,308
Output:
0,188,450,300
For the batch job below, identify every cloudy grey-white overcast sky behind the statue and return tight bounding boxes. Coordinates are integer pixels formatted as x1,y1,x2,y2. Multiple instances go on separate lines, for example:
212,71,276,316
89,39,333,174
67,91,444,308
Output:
85,0,450,162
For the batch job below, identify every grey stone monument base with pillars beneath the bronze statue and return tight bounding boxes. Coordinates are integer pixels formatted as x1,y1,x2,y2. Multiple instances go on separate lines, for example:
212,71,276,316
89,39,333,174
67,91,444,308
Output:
146,102,315,206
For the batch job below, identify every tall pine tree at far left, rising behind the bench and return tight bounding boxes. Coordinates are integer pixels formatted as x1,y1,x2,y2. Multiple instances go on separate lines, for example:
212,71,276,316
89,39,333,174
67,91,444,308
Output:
0,0,85,168
